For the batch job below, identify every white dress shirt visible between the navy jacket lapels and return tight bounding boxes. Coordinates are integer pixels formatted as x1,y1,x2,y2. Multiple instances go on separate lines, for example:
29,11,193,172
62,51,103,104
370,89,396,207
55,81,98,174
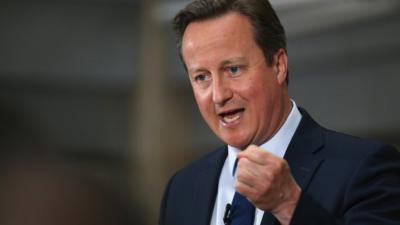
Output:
211,100,301,225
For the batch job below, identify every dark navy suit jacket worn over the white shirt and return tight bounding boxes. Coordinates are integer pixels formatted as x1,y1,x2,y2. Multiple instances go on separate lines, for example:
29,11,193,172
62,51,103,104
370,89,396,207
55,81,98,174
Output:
159,110,400,225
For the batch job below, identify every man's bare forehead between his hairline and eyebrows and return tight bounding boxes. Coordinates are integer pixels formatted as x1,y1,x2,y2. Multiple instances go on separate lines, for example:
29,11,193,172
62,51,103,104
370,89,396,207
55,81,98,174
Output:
182,12,256,67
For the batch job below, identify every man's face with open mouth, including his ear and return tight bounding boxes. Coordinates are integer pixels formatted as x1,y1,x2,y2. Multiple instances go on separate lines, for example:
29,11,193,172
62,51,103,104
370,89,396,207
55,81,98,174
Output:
181,12,290,149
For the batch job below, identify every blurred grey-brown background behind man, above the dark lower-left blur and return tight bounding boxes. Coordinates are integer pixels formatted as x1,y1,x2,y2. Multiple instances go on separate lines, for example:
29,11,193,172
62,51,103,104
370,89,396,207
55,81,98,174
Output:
0,0,400,224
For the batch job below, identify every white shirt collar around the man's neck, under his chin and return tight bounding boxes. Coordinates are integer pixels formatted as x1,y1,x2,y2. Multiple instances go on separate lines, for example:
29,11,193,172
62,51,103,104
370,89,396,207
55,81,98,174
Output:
228,99,302,174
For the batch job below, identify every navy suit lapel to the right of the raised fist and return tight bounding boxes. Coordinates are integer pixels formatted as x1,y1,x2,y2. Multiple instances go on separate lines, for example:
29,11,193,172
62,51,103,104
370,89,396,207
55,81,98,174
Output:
261,108,324,225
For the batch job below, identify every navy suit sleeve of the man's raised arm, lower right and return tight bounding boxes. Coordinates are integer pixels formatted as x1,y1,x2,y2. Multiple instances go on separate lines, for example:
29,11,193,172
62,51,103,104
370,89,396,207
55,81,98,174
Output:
290,146,400,225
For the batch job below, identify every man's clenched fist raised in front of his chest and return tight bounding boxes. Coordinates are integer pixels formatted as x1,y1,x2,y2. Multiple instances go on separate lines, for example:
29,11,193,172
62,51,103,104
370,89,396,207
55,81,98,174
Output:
235,145,301,225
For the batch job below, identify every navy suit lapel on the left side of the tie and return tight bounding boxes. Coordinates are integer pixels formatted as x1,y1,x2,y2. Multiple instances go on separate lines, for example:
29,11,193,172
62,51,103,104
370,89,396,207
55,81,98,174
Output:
191,146,227,225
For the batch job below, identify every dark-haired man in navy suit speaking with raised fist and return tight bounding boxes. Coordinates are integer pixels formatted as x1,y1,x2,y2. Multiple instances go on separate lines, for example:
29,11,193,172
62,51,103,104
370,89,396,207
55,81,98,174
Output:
160,0,400,225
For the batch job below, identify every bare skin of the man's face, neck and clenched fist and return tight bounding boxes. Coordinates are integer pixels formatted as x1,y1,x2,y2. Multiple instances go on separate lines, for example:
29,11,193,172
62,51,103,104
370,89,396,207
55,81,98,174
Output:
181,12,301,224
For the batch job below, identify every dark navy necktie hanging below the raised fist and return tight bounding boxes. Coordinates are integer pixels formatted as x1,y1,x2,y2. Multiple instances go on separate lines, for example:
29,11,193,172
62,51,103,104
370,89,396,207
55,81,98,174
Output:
230,160,255,225
